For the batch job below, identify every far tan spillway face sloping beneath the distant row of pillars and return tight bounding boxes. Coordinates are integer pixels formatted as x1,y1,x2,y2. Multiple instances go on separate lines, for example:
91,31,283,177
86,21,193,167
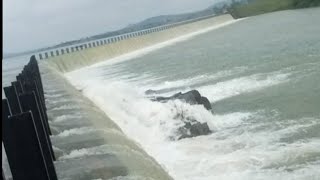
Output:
39,14,235,73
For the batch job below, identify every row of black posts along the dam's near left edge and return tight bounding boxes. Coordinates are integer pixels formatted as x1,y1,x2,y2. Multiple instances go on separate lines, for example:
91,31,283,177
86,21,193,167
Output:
2,55,58,180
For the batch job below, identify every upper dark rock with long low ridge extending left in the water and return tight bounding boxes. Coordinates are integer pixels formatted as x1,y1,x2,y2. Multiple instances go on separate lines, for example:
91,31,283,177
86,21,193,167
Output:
151,90,212,110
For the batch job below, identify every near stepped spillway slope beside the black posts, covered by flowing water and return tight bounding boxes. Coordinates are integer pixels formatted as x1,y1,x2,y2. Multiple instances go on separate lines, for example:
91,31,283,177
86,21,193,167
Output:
41,66,171,180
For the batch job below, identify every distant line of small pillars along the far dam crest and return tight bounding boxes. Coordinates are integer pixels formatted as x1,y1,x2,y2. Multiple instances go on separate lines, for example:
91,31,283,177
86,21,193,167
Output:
36,15,215,60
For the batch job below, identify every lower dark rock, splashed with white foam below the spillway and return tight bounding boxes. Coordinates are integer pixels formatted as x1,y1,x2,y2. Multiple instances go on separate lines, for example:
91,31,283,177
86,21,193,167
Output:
178,122,212,140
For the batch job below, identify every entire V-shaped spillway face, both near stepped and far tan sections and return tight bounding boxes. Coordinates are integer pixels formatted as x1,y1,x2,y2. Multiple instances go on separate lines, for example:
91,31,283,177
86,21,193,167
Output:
1,15,238,180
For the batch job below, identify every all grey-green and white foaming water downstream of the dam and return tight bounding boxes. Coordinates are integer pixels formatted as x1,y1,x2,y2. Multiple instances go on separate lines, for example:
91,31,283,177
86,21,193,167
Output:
66,8,320,180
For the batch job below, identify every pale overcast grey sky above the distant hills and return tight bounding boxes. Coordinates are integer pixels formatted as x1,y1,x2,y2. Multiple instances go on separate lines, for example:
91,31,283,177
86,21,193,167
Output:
3,0,225,53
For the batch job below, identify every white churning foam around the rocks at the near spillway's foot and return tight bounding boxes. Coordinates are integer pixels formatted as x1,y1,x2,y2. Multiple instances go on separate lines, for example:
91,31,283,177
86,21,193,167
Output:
68,63,320,180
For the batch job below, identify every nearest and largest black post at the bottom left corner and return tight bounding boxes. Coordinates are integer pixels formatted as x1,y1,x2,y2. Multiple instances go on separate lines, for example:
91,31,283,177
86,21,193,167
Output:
2,111,50,180
